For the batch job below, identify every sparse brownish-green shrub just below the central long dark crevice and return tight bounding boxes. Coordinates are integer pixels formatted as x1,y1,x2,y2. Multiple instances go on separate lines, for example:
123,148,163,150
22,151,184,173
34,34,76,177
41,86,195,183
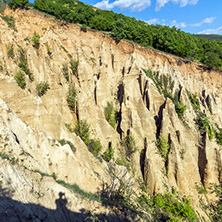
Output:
121,133,137,160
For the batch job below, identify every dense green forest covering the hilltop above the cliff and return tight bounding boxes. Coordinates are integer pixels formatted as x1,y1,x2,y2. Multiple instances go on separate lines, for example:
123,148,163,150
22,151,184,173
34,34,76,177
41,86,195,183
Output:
4,0,222,69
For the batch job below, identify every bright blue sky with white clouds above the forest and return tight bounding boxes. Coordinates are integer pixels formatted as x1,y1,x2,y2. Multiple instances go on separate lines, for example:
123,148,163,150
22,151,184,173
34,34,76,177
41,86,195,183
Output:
31,0,222,34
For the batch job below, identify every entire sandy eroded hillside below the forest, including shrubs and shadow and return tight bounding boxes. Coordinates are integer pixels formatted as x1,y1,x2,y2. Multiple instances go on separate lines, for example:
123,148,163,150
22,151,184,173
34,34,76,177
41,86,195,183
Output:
0,5,222,221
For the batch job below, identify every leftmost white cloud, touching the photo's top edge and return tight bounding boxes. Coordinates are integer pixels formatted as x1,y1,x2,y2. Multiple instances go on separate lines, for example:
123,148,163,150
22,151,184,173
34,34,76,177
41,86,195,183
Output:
94,0,151,12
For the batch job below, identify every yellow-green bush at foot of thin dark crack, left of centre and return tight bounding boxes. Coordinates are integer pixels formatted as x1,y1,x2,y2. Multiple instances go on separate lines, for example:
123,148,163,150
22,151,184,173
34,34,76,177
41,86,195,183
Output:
74,120,90,146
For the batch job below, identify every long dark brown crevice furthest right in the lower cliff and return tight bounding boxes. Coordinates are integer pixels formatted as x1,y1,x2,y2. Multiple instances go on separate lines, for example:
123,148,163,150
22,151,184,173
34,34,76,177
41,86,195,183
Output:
198,133,207,185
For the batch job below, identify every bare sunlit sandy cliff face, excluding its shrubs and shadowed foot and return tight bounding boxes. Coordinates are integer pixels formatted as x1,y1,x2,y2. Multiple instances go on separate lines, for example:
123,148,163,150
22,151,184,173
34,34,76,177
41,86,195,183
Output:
0,6,222,218
